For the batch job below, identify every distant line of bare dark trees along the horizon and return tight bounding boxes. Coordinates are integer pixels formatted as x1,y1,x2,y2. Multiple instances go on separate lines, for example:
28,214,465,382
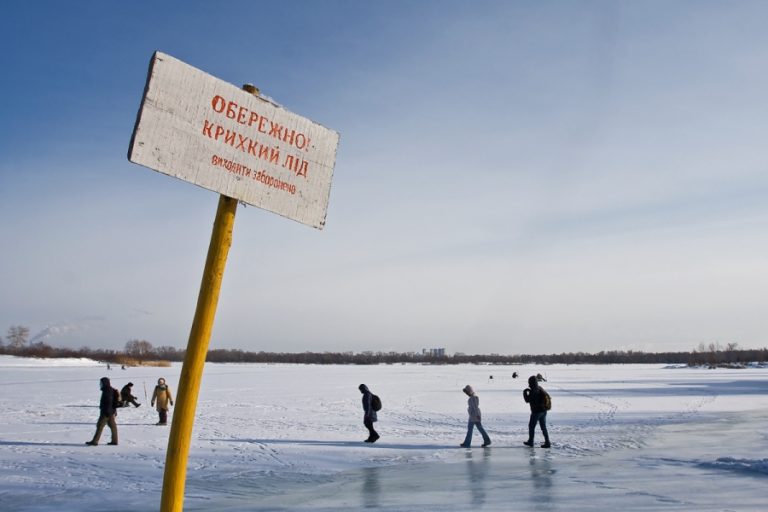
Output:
0,336,768,366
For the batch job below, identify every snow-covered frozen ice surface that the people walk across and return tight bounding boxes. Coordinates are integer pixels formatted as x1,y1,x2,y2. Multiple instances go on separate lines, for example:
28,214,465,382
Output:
0,356,768,512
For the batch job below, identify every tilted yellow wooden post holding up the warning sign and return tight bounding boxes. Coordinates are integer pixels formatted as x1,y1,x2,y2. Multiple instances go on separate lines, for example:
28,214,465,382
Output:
160,84,259,512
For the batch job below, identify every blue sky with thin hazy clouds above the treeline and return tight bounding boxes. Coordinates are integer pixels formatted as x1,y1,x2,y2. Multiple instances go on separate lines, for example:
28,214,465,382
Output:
0,1,768,354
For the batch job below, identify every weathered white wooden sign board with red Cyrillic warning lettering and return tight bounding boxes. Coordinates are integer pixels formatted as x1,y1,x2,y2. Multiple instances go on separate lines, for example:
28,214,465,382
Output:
128,52,339,229
